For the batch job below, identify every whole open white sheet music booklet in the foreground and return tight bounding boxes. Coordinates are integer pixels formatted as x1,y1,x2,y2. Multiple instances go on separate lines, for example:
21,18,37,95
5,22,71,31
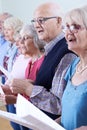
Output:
0,94,65,130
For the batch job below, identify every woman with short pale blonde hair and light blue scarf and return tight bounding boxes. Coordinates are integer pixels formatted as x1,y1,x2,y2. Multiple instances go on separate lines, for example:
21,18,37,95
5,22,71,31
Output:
3,17,23,72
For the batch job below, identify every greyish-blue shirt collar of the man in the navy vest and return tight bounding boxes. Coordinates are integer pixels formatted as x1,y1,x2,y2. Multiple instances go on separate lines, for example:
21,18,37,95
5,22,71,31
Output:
44,32,64,55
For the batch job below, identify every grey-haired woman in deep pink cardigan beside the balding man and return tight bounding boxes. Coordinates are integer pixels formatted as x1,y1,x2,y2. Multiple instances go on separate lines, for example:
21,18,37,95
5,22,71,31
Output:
13,25,45,81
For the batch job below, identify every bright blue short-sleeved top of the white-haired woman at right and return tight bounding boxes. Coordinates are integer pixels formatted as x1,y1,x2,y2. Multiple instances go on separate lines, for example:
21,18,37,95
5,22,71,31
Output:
61,58,87,130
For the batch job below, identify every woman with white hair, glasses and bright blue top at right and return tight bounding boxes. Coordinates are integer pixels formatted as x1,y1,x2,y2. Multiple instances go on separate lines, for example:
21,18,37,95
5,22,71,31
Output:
61,7,87,130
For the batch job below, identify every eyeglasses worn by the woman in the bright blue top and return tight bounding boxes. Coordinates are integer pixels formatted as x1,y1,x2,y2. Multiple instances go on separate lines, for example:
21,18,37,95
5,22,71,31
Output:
62,24,85,33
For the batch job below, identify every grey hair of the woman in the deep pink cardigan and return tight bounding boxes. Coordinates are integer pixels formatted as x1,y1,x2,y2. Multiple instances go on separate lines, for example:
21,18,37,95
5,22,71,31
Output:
20,24,45,51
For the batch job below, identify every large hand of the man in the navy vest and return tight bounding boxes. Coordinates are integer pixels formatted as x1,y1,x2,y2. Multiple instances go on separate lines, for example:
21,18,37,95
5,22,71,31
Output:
9,79,33,96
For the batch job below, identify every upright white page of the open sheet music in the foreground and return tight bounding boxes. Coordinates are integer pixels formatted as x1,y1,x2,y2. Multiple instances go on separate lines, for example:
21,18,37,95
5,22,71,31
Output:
16,94,65,130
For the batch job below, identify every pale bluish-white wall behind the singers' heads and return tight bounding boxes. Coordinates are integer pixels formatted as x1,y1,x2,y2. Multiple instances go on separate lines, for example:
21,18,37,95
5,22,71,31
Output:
0,0,87,23
